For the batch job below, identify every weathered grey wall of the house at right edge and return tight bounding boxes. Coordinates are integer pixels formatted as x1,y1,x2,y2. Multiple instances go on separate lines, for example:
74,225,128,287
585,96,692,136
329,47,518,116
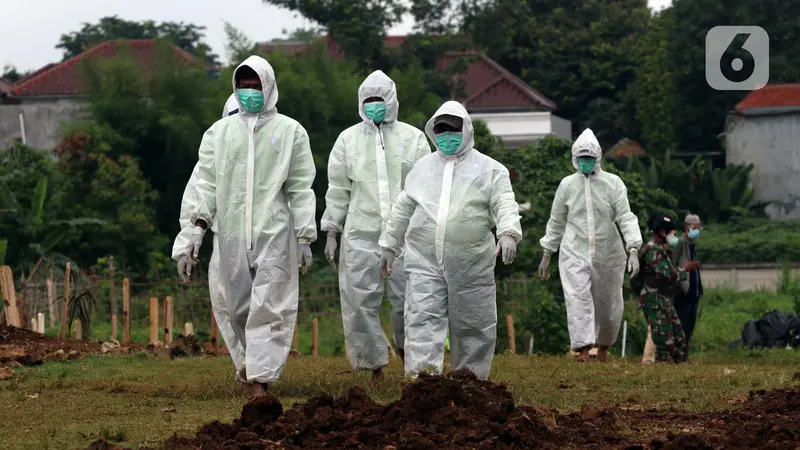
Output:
726,114,800,220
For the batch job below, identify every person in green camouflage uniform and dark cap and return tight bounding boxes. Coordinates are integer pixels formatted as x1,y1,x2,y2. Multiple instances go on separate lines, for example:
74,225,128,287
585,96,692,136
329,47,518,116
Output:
639,214,697,363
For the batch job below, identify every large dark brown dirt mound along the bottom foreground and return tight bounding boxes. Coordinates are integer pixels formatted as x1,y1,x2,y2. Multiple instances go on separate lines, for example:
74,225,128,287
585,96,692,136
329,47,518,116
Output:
89,373,800,450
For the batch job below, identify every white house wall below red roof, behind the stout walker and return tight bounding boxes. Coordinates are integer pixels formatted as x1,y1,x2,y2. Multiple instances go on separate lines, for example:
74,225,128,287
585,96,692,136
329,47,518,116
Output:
470,111,572,148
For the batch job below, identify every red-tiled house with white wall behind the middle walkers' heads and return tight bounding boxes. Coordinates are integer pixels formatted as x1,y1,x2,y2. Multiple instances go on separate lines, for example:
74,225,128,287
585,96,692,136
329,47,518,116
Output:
259,36,572,149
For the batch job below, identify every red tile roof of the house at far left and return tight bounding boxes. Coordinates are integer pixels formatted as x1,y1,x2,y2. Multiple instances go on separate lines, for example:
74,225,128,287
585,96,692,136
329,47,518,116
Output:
11,39,211,97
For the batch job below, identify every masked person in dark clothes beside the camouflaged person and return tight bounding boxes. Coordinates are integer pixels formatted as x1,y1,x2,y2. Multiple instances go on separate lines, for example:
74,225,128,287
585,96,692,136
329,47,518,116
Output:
671,213,703,348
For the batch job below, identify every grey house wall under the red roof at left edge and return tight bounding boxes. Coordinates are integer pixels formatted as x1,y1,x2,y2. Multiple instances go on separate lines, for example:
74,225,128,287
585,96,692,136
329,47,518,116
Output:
0,98,82,150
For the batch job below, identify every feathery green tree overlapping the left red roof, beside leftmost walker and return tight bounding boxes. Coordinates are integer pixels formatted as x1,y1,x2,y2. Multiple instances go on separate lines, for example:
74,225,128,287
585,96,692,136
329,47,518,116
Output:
83,43,222,241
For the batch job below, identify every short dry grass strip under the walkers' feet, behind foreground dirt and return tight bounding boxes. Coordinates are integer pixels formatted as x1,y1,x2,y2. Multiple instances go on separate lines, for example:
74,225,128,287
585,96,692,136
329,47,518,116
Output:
0,350,800,449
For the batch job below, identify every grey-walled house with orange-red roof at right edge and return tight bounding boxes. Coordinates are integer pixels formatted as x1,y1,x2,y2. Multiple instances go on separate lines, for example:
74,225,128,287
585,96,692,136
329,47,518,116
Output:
725,83,800,220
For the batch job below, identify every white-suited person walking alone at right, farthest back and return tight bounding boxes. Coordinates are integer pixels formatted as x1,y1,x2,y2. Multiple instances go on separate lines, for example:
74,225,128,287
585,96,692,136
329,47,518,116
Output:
539,128,642,361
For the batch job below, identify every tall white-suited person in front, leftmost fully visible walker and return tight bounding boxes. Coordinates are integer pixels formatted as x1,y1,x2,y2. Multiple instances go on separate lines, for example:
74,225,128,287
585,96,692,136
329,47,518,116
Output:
187,56,317,397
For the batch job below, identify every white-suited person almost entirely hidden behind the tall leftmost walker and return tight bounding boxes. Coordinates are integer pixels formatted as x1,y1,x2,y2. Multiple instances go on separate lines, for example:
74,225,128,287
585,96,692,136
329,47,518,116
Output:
172,94,246,382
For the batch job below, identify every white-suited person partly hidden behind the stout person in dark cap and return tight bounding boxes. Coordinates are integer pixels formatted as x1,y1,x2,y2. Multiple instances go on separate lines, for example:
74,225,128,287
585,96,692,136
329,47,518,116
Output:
321,70,431,378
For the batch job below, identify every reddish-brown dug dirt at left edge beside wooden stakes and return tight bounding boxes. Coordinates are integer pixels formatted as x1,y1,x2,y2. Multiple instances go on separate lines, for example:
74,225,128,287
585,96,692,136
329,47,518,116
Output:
0,325,143,367
